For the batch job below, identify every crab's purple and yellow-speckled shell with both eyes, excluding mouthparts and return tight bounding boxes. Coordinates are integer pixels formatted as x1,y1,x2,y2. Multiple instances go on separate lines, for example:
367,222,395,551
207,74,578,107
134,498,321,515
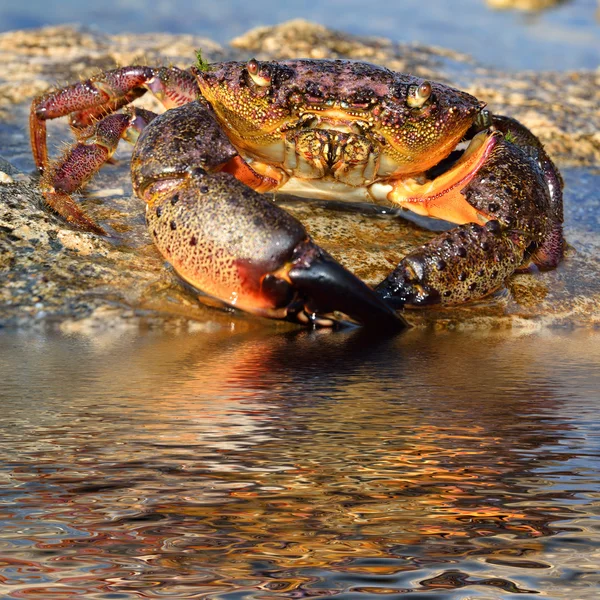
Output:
195,59,485,180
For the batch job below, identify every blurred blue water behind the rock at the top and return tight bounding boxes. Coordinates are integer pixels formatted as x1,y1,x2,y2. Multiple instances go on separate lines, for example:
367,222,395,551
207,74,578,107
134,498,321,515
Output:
0,0,600,70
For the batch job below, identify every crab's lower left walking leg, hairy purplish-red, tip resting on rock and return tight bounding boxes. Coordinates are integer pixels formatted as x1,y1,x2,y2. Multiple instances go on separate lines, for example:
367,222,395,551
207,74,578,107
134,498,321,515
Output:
40,109,156,234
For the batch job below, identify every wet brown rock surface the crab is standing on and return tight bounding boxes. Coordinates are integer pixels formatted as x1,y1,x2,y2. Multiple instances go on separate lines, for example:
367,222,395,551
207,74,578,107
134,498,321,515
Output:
0,21,600,331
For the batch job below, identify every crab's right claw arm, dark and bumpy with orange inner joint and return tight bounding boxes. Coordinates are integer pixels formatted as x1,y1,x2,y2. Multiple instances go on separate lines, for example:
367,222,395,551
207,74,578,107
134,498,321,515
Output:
376,132,556,306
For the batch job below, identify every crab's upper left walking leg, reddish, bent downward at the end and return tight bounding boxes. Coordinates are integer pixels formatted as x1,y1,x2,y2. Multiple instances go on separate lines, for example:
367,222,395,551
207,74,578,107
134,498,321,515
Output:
29,66,198,173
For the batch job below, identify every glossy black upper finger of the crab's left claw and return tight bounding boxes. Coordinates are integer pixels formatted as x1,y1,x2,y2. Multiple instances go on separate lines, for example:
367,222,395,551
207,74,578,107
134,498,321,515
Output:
288,246,409,331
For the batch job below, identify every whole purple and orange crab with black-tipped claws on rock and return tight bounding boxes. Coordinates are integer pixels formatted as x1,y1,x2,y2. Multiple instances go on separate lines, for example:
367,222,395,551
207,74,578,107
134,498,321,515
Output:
31,60,563,325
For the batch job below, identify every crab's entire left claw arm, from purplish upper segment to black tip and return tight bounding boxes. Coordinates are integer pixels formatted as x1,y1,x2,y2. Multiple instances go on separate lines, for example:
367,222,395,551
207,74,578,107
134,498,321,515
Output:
132,102,406,330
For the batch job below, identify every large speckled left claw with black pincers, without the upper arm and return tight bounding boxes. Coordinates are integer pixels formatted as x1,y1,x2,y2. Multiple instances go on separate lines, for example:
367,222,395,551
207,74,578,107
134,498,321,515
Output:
140,168,406,330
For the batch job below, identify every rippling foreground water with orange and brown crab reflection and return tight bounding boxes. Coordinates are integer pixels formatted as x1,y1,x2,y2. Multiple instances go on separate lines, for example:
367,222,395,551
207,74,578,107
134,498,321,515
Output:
0,329,600,600
